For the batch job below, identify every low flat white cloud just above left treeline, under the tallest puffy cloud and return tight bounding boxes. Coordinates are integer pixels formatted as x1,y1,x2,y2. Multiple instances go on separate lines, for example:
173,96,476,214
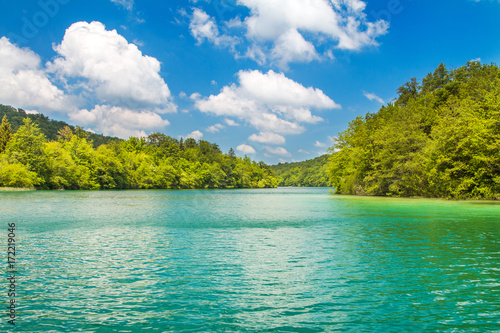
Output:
69,105,169,139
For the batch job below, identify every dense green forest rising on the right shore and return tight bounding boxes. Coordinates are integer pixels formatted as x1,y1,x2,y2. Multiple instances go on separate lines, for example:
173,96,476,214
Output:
328,61,500,199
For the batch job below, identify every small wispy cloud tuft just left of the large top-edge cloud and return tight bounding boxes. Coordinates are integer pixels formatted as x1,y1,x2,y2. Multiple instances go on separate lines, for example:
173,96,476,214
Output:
189,8,236,47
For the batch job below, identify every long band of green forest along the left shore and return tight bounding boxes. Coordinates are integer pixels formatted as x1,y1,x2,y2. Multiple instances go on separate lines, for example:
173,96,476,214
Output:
0,106,278,190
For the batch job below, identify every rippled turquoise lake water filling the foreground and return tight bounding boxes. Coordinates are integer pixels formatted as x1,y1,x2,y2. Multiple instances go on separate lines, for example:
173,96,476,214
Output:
0,188,500,332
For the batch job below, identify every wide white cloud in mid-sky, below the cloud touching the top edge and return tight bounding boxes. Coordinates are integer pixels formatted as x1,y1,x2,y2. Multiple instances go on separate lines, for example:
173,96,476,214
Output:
193,70,340,135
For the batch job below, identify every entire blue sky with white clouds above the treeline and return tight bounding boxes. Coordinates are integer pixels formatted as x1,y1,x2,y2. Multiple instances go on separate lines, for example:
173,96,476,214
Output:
0,0,500,164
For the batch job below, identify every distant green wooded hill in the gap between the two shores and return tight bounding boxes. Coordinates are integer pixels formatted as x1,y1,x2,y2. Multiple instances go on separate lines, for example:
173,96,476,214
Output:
271,155,329,187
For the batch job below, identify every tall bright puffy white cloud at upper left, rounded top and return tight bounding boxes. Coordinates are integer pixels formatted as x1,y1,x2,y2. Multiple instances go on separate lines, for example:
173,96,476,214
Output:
49,22,176,112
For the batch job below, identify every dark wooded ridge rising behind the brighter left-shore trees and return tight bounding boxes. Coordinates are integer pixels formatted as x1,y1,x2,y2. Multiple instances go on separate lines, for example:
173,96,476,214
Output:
0,104,121,147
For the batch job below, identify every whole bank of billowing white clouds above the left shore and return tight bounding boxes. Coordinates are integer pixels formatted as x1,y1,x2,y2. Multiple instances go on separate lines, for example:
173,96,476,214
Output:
0,21,176,138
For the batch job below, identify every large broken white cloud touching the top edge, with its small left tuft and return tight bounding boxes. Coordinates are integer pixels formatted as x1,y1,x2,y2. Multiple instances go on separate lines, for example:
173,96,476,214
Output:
191,0,389,69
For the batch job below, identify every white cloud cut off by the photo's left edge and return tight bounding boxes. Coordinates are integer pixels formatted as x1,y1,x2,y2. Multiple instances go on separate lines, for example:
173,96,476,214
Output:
0,37,76,113
